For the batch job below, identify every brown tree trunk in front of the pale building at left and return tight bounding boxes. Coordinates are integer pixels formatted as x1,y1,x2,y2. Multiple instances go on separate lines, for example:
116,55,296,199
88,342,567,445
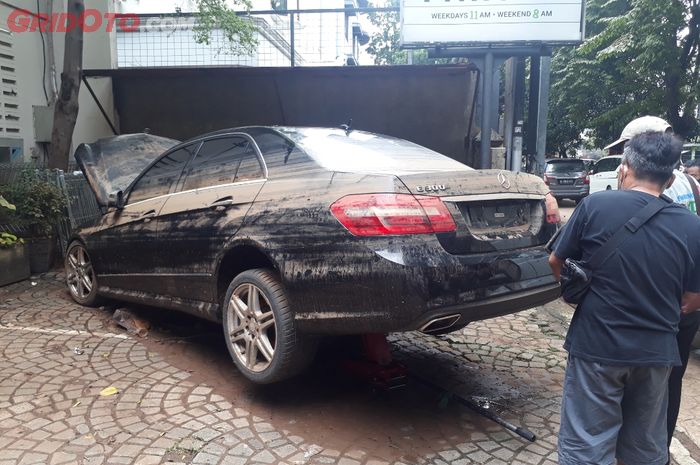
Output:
49,0,85,171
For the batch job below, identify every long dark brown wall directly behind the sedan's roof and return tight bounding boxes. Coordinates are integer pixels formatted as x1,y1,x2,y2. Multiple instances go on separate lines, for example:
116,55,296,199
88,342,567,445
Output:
106,66,476,161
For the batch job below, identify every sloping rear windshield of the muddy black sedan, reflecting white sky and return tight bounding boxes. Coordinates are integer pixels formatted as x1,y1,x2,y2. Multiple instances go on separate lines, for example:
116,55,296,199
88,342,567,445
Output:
277,128,471,174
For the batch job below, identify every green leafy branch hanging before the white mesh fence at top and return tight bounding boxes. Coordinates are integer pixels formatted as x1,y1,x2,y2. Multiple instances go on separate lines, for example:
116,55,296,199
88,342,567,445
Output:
194,0,258,55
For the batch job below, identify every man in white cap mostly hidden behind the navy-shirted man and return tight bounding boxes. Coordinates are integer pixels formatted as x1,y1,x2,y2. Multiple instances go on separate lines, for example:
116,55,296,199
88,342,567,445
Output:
606,116,700,460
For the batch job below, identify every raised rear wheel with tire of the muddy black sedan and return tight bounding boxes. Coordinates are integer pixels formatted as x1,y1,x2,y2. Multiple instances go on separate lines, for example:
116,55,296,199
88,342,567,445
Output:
222,269,318,384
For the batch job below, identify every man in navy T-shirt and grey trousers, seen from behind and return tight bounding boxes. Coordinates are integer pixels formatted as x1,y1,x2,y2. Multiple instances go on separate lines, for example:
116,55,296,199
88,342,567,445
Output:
550,131,700,465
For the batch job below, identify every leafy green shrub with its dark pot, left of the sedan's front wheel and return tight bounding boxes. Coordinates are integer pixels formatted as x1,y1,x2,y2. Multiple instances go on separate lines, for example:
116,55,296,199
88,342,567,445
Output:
5,169,65,273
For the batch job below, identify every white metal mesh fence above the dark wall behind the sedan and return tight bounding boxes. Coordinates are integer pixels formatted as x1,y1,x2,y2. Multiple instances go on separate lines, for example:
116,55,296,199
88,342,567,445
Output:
117,8,398,68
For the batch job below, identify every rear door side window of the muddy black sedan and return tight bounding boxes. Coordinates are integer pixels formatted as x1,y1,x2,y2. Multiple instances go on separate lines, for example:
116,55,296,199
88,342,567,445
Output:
182,136,263,191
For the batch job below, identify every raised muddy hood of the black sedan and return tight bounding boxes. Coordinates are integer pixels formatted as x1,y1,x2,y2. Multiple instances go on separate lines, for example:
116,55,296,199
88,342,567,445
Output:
75,134,180,207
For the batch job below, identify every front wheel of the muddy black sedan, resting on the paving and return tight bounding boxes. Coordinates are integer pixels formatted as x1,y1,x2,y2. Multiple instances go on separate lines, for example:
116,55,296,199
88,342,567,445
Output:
64,241,100,307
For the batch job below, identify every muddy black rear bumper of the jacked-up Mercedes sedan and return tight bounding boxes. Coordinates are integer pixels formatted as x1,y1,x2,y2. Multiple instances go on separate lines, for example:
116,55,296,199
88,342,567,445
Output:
285,238,559,334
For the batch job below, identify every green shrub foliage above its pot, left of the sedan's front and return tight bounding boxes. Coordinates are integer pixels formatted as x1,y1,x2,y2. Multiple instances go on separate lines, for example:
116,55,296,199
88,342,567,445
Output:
0,168,65,237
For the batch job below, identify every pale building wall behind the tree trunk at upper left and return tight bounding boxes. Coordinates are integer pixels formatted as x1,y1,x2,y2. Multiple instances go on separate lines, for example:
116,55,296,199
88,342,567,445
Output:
0,0,117,161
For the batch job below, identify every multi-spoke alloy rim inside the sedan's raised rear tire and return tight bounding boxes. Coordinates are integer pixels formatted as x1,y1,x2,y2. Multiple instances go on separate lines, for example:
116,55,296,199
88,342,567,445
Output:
227,283,277,373
